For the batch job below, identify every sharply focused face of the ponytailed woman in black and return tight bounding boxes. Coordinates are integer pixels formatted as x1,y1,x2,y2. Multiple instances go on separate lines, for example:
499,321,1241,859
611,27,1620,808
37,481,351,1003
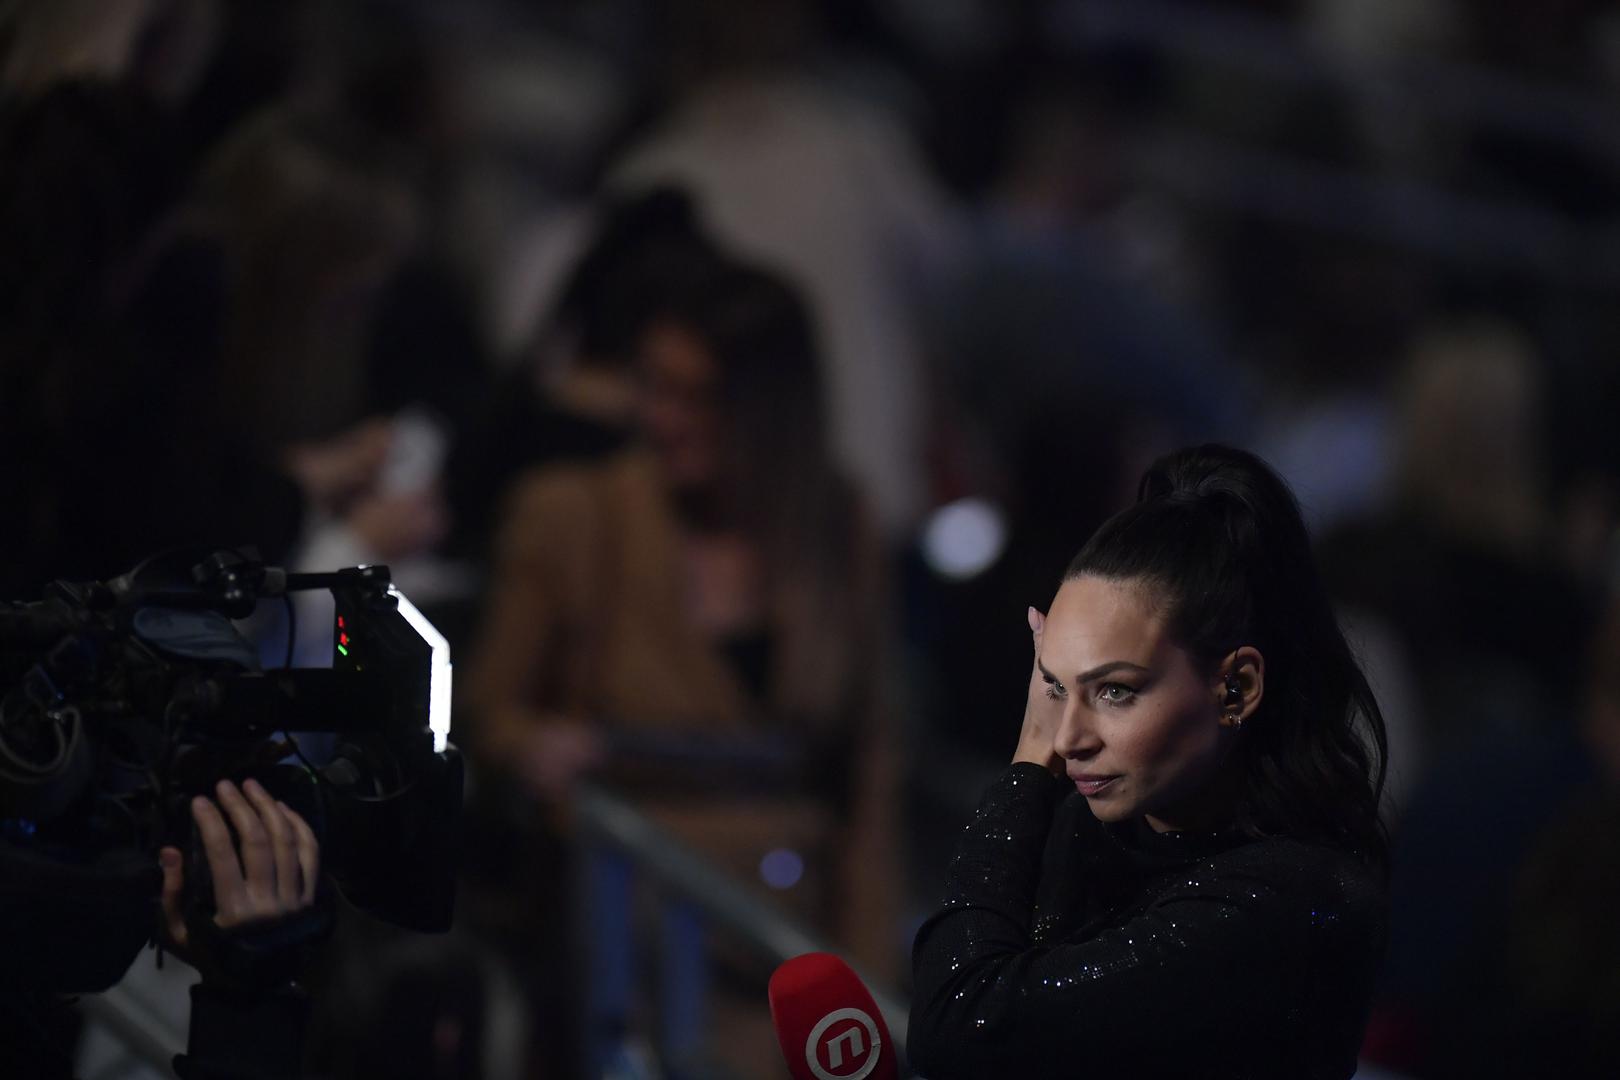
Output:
1035,575,1230,831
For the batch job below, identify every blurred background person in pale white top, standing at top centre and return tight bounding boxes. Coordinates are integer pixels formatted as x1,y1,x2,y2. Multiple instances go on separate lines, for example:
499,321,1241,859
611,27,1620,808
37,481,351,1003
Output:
609,0,956,539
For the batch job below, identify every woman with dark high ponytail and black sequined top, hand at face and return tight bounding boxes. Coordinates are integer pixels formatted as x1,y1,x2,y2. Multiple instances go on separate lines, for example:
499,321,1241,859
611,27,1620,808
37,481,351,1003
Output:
909,445,1387,1080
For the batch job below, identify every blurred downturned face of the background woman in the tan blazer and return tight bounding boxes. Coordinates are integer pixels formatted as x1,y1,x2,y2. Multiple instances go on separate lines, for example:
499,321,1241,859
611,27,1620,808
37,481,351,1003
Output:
637,322,721,489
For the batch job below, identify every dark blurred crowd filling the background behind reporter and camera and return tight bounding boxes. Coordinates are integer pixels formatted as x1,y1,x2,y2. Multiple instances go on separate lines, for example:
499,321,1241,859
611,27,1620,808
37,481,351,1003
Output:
0,0,1620,1080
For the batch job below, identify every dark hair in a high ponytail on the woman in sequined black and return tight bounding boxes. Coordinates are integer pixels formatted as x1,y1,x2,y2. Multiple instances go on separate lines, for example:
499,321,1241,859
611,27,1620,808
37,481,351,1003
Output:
1064,445,1388,866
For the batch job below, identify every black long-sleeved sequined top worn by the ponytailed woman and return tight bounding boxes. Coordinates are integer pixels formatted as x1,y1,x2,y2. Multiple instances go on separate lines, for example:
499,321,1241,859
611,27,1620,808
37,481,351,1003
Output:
907,764,1385,1080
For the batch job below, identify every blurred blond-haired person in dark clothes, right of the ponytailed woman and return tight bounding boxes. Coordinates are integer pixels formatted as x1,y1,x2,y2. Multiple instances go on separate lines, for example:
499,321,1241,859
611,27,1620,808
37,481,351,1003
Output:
1354,317,1597,1077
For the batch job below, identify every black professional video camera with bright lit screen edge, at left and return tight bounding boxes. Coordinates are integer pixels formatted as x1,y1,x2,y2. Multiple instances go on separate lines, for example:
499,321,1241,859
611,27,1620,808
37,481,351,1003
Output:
0,551,462,991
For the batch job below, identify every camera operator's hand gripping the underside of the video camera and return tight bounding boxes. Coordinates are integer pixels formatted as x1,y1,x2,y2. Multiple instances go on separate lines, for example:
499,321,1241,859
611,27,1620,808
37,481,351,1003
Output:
159,780,321,954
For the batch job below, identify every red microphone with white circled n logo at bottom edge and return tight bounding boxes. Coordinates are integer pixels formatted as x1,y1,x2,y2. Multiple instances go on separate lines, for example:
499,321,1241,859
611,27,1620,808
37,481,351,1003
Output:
771,952,899,1080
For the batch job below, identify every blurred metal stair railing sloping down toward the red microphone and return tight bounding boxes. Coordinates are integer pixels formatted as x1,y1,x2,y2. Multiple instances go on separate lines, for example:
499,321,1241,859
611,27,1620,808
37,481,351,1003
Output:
577,787,909,1077
